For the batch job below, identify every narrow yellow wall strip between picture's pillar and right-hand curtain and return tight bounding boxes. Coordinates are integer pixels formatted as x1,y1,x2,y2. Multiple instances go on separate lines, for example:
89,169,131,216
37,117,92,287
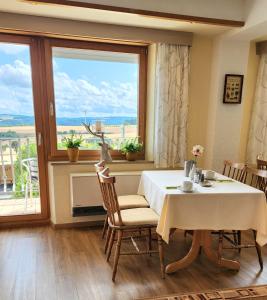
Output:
238,42,260,162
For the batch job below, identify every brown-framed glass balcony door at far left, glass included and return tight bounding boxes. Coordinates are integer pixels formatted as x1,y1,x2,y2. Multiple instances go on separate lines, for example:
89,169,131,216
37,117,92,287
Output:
0,34,48,223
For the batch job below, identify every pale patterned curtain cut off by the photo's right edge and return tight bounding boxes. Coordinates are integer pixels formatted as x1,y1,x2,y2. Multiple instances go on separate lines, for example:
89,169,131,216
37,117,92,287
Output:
247,54,267,163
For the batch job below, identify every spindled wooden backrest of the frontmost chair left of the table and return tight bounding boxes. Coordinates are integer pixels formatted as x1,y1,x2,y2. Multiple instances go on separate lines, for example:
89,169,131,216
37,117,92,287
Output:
98,168,123,226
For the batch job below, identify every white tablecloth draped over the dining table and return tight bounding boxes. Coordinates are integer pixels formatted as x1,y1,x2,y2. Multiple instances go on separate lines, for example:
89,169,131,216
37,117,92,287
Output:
138,171,267,246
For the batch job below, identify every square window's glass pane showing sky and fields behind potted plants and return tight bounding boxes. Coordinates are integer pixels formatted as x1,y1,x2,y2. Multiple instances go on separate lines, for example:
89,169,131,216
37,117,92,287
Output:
53,47,139,150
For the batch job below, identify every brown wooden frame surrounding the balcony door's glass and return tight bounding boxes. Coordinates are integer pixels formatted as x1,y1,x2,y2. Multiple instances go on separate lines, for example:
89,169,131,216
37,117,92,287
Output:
0,33,50,227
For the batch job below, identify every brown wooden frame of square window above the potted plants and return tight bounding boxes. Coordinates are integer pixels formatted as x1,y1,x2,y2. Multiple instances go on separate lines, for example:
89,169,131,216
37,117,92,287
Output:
44,38,148,161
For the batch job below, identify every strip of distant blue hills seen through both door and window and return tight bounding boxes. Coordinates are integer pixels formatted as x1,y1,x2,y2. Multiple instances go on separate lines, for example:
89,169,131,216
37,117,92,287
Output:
0,114,137,127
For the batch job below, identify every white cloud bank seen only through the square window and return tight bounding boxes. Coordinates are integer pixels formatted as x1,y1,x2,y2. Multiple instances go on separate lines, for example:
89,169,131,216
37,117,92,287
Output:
54,72,137,117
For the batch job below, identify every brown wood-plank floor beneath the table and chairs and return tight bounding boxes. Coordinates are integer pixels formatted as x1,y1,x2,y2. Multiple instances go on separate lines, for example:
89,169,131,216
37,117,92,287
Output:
0,227,267,300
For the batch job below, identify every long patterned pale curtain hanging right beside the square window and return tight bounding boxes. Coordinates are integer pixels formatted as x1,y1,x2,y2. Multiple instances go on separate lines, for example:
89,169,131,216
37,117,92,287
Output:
154,44,189,168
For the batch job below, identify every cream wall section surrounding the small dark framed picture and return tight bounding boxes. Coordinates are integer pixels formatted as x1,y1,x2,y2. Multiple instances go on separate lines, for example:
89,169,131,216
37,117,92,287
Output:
205,37,250,171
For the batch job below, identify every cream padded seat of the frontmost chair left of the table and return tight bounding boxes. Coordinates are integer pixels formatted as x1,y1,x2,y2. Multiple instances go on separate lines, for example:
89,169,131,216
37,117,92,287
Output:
115,208,159,226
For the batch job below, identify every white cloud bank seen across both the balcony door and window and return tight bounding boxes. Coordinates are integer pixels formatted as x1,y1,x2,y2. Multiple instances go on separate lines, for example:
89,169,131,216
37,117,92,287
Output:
0,60,137,117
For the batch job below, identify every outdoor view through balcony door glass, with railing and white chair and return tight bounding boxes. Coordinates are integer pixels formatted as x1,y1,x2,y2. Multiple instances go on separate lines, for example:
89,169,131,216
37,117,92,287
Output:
0,43,40,216
